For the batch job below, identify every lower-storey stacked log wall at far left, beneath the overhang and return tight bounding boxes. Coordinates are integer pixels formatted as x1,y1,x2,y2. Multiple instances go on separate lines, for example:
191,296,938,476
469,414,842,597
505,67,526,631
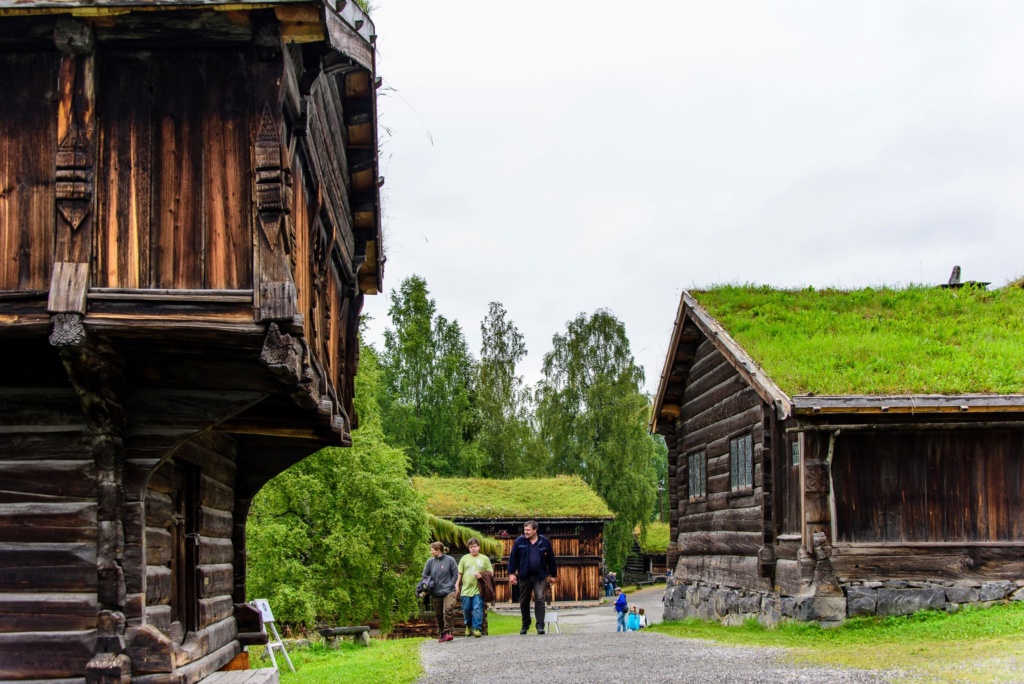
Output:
0,385,100,681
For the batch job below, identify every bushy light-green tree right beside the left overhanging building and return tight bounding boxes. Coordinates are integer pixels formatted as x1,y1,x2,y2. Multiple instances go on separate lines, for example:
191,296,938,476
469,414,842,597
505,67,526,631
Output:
247,346,430,630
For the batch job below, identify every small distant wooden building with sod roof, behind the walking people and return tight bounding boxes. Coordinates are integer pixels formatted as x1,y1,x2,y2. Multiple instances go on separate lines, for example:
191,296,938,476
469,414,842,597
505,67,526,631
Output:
413,476,613,603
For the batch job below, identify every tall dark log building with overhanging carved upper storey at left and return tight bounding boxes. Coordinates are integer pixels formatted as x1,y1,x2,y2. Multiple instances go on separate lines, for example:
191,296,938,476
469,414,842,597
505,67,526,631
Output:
0,0,383,684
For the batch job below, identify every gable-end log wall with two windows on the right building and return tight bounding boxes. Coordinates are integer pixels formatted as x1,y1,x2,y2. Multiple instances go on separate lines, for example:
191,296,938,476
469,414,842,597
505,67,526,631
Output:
670,339,771,590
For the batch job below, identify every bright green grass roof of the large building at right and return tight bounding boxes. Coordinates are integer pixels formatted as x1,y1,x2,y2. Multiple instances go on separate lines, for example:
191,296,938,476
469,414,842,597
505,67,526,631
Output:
690,286,1024,396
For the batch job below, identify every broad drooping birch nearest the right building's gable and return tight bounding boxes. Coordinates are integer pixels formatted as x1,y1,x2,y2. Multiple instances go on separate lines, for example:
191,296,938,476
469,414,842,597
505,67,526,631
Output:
538,309,657,569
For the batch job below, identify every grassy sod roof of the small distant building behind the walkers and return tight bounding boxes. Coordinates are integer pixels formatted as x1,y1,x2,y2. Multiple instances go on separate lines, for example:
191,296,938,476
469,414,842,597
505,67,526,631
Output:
413,476,612,519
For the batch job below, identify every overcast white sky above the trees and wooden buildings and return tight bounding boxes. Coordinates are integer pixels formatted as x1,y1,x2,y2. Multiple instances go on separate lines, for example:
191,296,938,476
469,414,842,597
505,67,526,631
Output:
365,0,1024,391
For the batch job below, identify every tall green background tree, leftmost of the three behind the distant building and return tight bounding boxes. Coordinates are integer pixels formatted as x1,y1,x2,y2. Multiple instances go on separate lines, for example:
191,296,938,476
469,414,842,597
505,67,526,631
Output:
382,275,483,475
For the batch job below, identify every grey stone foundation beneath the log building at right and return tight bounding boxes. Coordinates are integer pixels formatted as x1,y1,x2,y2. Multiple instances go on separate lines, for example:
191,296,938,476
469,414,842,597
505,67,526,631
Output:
665,578,1024,627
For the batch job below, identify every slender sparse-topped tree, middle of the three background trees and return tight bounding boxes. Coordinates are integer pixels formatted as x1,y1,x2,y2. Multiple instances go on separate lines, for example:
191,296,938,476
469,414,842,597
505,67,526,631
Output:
476,302,547,478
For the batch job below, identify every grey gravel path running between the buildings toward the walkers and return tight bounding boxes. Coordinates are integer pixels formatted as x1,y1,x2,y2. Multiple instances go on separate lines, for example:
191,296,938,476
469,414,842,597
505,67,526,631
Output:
420,588,890,684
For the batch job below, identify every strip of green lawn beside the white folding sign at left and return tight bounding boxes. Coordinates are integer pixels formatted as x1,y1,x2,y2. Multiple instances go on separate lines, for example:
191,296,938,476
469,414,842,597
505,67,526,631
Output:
250,639,424,684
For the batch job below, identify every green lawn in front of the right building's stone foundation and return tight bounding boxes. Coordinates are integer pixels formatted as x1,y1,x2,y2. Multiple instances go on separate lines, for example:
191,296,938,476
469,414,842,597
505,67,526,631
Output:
650,603,1024,683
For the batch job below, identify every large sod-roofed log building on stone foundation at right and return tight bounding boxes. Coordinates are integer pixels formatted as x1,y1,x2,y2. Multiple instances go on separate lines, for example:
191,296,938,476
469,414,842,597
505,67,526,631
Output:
651,284,1024,623
